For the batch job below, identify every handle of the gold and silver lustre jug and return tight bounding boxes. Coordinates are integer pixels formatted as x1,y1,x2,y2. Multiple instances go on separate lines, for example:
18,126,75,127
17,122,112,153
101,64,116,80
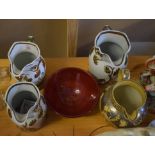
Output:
117,69,130,81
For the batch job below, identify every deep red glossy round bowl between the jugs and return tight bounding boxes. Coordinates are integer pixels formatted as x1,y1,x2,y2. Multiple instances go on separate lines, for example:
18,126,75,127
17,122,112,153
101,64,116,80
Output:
44,68,100,117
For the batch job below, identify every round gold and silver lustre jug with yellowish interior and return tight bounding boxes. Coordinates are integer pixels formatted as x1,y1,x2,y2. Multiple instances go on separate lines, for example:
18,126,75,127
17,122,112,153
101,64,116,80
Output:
99,70,147,127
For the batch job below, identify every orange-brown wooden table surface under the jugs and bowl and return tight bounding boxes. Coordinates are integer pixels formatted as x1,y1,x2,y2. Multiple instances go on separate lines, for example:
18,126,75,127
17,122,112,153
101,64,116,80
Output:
0,56,155,136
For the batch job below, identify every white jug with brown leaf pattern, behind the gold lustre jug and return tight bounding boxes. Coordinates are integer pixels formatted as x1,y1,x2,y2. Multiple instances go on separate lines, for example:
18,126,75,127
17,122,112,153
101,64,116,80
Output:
89,25,131,83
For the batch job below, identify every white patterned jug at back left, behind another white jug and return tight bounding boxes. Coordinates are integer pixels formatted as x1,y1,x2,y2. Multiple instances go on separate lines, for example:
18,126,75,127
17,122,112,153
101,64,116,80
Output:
8,37,46,85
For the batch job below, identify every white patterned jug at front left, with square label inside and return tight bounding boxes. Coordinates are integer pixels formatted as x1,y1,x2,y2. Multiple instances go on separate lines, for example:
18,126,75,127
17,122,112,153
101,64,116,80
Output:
5,82,47,129
